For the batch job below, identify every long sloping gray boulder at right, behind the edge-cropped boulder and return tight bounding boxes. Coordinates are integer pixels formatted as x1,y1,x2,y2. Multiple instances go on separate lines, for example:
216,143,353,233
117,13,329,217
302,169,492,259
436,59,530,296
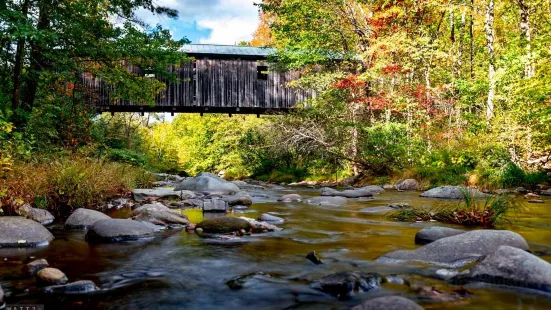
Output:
377,230,528,268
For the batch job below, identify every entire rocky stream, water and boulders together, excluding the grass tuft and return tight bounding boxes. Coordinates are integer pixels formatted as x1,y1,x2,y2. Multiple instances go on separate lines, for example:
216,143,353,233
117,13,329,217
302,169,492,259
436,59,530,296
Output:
0,174,551,309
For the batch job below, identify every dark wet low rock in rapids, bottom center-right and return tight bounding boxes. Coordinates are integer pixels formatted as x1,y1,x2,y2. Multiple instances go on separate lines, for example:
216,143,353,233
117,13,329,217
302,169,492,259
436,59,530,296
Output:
312,271,382,299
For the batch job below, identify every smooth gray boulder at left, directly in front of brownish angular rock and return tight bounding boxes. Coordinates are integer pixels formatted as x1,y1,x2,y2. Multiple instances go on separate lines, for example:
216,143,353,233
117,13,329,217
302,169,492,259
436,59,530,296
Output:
86,219,153,243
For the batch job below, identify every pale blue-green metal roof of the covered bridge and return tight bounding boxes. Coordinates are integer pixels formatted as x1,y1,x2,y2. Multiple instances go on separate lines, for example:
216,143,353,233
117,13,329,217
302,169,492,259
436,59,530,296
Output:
182,44,275,57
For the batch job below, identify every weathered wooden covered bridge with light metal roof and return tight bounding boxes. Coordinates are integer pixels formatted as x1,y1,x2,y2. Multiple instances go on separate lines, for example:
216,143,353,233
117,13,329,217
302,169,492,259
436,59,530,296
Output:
82,44,313,114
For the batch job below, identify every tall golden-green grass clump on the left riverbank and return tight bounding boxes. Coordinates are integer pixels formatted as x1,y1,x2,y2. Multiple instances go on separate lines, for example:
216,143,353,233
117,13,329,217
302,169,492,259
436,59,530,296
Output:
0,157,153,214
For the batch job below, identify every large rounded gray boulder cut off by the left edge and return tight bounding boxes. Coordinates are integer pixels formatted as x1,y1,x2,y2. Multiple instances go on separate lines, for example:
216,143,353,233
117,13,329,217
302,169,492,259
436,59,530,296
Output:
0,216,54,248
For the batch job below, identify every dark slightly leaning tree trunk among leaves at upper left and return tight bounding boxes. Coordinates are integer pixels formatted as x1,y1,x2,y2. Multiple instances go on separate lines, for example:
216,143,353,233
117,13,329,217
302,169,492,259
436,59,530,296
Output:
20,0,56,125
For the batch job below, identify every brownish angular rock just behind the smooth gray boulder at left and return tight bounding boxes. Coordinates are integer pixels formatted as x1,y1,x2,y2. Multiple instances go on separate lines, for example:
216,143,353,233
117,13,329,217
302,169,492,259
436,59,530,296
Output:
130,204,190,226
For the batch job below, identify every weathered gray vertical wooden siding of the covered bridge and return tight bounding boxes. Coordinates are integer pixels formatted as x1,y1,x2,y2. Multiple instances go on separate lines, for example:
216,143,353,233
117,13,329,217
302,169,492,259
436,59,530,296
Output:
82,58,313,113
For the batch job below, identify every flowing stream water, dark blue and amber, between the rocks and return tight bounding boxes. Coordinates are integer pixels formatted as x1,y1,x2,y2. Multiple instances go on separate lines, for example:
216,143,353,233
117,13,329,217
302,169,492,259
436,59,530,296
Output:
0,187,551,310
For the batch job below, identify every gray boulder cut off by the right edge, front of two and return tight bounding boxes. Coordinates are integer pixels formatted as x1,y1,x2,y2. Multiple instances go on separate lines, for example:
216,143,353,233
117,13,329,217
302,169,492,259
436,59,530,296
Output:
451,245,551,293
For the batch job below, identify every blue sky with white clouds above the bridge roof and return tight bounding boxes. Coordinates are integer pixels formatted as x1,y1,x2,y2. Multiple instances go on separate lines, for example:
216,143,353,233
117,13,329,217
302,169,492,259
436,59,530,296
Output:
138,0,260,45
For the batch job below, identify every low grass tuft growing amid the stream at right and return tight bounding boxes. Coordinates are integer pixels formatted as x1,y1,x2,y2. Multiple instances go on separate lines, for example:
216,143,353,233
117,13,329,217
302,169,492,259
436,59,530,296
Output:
385,191,523,228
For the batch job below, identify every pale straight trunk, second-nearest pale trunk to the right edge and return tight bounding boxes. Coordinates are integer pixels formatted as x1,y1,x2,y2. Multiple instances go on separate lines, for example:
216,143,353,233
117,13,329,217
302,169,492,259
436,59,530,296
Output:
484,0,496,120
